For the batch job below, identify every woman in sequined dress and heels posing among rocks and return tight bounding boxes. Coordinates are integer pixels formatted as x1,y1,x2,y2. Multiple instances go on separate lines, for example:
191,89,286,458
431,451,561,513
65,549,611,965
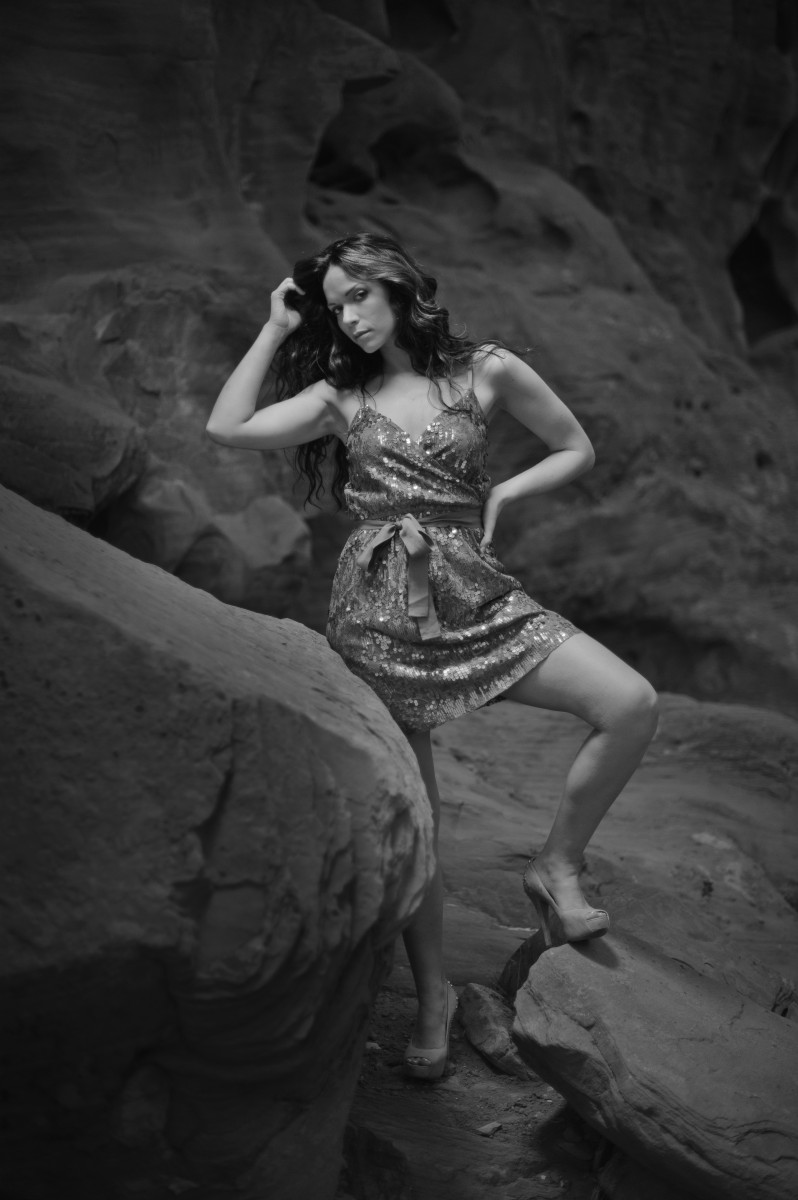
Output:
208,234,656,1079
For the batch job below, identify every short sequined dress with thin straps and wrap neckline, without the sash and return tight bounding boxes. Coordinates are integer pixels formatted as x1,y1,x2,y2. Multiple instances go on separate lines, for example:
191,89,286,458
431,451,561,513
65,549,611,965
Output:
326,389,577,733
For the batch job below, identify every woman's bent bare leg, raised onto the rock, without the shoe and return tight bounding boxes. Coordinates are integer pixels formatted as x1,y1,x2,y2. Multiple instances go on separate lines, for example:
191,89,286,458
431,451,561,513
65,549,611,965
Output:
505,634,656,908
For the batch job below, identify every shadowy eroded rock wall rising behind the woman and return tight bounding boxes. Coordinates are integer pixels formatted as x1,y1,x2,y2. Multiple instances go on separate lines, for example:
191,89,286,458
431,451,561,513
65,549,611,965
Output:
0,0,798,710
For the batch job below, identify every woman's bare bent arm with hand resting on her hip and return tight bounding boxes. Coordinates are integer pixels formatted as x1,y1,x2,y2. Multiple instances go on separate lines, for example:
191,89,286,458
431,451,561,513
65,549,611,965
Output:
480,349,595,546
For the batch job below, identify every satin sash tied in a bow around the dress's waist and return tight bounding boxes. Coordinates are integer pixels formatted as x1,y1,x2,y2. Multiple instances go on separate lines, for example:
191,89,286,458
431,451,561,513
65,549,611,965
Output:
356,508,482,642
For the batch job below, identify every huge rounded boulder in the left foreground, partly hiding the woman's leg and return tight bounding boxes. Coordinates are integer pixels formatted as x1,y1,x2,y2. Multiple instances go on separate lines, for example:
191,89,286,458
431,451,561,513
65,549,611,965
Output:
0,490,431,1200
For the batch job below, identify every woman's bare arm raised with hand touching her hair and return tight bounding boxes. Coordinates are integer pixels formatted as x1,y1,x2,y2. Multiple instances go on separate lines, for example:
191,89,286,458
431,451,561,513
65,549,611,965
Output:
205,278,346,450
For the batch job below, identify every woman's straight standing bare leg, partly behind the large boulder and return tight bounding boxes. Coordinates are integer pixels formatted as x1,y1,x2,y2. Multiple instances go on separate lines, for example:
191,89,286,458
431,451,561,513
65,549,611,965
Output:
403,733,445,1048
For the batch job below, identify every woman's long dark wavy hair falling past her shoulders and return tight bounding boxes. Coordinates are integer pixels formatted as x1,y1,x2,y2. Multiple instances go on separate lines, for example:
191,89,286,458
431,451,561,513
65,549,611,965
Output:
274,233,498,508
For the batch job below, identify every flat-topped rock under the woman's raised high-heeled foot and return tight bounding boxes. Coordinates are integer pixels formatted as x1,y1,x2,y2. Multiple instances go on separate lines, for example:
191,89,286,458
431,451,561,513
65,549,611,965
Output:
514,935,798,1200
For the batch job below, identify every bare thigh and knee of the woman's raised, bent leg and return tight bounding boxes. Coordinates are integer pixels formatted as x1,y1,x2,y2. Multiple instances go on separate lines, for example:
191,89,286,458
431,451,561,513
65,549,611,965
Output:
504,634,656,728
